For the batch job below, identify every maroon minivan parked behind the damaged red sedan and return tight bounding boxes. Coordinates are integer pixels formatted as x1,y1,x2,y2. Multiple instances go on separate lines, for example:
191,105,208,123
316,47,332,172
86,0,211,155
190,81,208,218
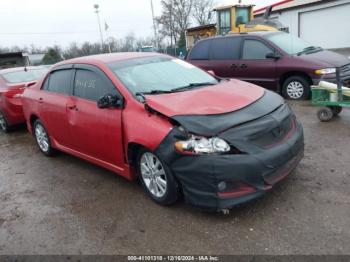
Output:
187,31,350,100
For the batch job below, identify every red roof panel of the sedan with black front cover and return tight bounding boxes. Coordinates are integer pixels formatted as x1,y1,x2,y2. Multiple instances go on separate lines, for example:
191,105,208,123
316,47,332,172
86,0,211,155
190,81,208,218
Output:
57,52,166,65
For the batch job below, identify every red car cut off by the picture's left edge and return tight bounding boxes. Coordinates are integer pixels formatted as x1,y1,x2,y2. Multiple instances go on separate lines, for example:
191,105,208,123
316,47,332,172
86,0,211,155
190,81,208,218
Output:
0,67,48,132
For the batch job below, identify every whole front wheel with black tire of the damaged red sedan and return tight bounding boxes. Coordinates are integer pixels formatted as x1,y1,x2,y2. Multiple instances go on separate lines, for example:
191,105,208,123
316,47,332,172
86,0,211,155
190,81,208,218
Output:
137,149,179,206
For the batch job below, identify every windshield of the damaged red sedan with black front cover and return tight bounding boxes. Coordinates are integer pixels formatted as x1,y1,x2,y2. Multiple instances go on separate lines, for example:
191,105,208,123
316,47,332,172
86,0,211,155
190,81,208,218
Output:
109,56,218,95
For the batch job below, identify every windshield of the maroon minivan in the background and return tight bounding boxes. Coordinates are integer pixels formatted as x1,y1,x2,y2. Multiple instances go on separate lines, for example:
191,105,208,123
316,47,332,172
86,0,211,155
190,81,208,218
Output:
266,32,322,55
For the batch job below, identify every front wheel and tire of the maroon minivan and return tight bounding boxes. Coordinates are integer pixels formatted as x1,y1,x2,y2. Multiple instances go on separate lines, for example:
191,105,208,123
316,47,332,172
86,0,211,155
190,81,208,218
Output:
282,76,310,100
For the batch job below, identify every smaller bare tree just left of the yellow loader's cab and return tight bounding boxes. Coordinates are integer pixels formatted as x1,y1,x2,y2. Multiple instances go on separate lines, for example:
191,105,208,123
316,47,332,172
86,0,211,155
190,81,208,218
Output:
192,0,214,25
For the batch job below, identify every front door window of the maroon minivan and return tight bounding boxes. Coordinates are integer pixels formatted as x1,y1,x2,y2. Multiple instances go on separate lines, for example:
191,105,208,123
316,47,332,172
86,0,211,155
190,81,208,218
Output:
242,40,273,60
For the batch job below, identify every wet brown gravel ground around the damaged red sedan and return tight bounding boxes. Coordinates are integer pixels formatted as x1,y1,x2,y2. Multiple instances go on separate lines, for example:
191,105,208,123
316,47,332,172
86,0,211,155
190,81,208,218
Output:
0,102,350,255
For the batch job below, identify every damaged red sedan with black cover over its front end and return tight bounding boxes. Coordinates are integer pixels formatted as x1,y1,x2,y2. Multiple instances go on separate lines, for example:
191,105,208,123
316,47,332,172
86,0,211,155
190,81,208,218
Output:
23,53,304,210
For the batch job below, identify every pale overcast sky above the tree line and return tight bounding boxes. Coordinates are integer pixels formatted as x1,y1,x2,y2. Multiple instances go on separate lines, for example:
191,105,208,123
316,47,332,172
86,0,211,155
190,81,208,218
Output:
0,0,278,47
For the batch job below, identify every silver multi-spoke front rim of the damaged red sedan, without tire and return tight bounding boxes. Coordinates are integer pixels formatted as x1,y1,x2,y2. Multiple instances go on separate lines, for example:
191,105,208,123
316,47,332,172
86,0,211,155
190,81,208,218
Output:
140,152,167,198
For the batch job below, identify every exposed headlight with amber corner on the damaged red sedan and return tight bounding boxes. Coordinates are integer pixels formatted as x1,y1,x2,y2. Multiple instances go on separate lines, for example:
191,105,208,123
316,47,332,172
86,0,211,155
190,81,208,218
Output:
175,135,230,154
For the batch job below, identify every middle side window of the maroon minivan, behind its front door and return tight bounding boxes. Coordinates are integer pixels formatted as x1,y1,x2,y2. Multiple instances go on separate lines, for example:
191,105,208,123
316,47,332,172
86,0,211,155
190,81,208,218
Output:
210,37,241,60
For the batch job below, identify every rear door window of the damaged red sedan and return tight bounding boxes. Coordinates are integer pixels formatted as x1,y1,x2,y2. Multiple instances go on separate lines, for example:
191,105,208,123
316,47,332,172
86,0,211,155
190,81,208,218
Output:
44,69,73,94
